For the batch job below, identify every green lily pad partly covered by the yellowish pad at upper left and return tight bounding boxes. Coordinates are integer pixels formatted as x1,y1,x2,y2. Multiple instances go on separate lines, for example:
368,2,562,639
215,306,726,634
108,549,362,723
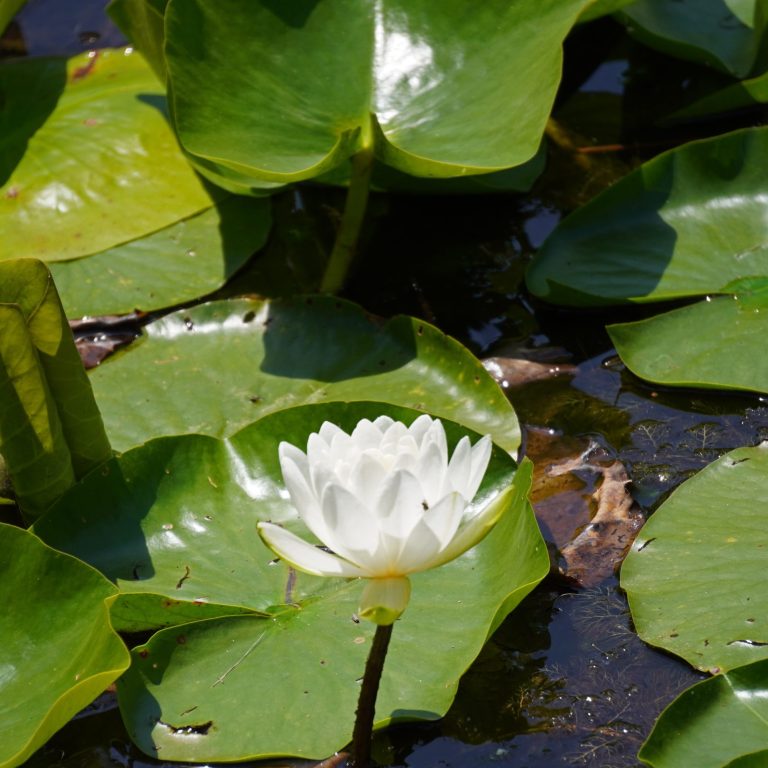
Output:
51,196,271,317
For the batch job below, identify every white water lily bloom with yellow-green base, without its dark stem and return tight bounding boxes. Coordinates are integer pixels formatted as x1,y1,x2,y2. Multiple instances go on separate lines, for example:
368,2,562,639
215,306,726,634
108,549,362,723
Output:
259,415,502,625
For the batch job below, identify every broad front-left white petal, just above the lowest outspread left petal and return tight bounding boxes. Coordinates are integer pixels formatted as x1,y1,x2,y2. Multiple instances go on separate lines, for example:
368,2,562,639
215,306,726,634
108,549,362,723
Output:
320,483,383,574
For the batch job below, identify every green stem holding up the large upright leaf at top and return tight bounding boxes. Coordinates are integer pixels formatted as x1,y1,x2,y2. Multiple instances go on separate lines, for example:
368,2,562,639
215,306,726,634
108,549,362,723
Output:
320,146,373,294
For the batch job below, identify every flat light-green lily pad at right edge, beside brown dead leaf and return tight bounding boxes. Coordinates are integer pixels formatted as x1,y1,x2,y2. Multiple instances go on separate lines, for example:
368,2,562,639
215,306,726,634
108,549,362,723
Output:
621,443,768,672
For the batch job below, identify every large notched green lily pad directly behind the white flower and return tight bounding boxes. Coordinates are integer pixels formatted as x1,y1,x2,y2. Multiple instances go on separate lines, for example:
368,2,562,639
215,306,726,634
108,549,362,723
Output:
37,403,549,761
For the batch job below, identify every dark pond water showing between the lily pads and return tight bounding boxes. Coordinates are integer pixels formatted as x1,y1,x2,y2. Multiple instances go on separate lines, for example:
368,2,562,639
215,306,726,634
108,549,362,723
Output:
3,0,768,768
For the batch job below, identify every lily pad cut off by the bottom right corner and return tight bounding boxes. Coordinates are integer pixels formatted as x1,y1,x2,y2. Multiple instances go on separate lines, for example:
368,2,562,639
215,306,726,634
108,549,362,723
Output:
639,661,768,768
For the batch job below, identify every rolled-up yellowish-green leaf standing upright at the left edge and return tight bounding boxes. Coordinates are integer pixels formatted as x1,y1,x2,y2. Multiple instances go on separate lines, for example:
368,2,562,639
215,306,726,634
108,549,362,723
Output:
0,259,112,519
